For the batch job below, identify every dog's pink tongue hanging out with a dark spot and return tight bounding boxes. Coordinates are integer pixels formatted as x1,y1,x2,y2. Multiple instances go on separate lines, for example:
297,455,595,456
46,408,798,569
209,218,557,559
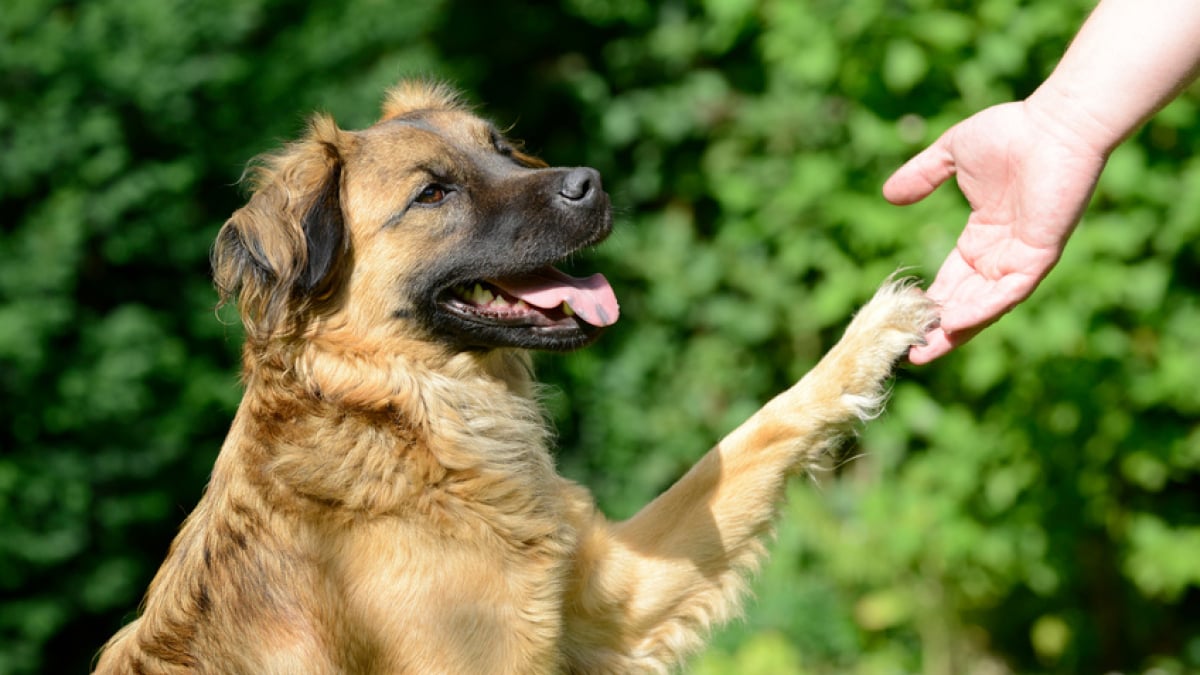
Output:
488,267,620,325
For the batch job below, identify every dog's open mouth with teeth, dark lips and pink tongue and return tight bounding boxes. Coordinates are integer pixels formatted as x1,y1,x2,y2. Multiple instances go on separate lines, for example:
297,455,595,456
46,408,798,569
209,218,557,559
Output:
438,265,620,350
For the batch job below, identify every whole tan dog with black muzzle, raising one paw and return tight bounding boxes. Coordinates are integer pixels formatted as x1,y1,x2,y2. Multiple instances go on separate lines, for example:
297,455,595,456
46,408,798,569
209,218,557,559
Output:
98,83,934,674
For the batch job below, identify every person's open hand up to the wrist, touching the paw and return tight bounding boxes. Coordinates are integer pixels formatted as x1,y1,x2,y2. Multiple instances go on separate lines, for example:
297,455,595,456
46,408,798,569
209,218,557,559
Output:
883,101,1108,364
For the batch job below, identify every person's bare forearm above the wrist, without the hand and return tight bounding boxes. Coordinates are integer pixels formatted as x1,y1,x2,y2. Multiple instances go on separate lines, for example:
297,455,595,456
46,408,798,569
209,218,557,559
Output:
1027,0,1200,156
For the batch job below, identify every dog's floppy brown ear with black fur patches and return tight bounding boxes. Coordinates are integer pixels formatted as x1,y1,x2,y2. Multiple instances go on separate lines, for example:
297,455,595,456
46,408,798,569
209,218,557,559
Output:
212,115,349,339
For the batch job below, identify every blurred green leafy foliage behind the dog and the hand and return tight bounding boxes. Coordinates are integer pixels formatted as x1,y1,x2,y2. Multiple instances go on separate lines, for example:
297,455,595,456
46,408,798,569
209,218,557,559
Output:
0,0,1200,675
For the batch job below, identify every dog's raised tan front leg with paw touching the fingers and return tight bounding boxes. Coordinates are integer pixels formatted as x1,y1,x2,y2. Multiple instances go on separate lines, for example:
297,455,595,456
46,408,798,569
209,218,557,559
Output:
566,276,935,673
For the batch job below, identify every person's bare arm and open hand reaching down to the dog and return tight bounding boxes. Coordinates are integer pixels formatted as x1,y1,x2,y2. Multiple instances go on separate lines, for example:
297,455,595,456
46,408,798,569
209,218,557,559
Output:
883,0,1200,364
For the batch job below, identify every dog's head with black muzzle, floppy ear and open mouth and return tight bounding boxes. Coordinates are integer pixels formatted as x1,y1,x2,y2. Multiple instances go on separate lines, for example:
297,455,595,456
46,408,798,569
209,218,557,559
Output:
212,83,618,350
